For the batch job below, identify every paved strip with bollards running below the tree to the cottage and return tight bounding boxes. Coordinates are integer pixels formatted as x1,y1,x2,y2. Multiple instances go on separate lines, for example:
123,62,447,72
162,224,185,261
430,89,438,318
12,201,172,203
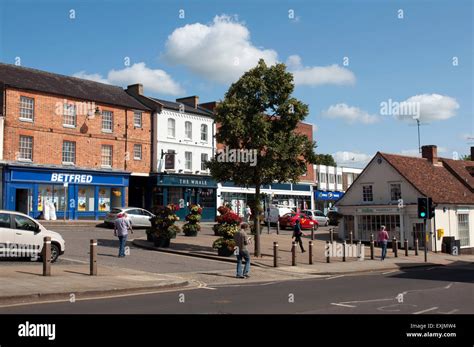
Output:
133,224,474,275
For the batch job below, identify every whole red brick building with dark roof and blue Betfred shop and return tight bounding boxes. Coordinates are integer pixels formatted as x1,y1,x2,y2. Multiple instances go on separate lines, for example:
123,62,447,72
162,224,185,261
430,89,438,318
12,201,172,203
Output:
0,64,151,219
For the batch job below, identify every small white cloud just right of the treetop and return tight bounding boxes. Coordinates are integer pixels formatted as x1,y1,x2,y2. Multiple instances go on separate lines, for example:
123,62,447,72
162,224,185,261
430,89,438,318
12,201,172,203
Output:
286,55,356,86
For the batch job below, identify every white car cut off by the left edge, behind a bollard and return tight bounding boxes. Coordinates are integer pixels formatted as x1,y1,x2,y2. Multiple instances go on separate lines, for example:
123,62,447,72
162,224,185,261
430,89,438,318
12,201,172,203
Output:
0,210,66,262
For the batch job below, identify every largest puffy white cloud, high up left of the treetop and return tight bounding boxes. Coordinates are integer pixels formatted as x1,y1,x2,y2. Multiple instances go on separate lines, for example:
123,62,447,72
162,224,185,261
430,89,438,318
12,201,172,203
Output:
164,15,278,83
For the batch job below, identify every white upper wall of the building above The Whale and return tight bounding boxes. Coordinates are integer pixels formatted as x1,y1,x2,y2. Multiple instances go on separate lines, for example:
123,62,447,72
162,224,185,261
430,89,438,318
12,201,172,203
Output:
154,109,214,174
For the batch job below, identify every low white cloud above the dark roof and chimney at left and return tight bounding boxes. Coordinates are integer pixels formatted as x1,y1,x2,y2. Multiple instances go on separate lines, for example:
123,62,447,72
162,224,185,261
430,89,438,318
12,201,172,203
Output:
73,62,185,95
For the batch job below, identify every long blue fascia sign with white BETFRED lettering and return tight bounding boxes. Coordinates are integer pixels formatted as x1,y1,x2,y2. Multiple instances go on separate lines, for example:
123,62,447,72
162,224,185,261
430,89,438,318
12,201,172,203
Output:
10,169,128,186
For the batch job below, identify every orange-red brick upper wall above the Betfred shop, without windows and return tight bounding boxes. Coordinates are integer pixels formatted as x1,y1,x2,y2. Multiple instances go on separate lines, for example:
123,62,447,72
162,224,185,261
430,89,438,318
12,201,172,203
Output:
4,88,151,173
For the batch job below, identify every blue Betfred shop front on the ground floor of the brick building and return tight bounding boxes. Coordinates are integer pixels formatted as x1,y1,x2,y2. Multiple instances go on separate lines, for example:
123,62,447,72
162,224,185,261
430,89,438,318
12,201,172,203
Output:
3,166,129,219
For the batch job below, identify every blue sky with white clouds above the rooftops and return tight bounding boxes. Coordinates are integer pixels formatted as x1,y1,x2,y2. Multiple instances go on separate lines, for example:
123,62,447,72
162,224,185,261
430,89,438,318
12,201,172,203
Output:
0,0,474,166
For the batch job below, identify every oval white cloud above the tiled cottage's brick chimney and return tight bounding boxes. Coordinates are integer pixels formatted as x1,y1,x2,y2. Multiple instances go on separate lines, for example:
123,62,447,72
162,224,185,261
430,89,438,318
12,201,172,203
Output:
397,94,459,122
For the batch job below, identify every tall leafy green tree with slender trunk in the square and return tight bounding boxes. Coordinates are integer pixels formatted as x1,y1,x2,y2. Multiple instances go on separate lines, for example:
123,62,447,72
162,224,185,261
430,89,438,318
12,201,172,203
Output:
207,59,316,257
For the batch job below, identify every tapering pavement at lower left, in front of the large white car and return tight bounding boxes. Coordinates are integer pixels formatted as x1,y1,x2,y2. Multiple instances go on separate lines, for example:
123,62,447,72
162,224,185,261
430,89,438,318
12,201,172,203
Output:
0,263,190,306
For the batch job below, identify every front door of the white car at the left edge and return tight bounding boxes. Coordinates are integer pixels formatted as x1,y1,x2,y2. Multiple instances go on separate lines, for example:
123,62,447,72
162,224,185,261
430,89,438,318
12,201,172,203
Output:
12,214,43,256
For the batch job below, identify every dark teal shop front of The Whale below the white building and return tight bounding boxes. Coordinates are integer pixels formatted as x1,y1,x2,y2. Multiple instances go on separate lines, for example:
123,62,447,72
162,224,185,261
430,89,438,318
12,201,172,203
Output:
152,174,217,222
